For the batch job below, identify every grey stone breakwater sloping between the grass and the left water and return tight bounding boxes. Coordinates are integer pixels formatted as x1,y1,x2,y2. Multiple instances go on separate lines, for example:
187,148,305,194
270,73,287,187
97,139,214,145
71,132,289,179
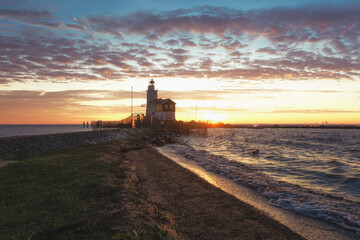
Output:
0,129,134,161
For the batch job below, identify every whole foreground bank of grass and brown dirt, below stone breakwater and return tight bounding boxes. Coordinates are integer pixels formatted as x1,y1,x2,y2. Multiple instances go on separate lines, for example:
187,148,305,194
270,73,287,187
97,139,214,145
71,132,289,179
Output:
0,135,304,239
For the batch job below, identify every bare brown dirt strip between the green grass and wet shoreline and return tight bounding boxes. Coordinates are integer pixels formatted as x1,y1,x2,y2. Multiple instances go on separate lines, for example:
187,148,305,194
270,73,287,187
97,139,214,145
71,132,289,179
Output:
127,146,303,239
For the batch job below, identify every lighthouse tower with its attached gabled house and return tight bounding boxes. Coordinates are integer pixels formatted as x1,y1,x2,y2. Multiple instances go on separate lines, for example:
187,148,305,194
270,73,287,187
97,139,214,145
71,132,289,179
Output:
146,79,176,121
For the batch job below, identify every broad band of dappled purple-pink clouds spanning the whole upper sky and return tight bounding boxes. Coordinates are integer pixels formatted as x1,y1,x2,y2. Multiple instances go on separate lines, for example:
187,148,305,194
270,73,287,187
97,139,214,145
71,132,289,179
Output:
0,4,360,84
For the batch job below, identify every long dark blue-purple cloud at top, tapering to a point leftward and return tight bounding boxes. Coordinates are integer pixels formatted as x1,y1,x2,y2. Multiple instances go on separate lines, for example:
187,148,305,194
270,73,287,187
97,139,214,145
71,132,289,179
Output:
75,4,360,46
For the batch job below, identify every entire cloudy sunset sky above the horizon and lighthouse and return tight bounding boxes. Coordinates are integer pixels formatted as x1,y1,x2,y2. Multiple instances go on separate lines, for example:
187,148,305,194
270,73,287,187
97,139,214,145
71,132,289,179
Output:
0,0,360,124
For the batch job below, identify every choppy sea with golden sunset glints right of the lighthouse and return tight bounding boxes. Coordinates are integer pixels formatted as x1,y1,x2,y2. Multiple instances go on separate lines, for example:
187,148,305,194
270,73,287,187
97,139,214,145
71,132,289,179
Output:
167,128,360,235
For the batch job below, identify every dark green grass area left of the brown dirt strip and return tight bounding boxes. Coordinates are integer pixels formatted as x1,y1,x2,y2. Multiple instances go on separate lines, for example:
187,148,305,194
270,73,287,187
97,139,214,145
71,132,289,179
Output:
0,140,166,239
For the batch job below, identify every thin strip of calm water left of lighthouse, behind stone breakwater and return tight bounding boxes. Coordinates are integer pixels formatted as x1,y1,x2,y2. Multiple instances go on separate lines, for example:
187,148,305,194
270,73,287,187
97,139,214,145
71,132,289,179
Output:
0,124,91,138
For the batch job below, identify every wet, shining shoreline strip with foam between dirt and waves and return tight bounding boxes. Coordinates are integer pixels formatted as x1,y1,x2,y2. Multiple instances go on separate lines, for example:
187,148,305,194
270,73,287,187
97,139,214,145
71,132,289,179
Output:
157,146,358,240
